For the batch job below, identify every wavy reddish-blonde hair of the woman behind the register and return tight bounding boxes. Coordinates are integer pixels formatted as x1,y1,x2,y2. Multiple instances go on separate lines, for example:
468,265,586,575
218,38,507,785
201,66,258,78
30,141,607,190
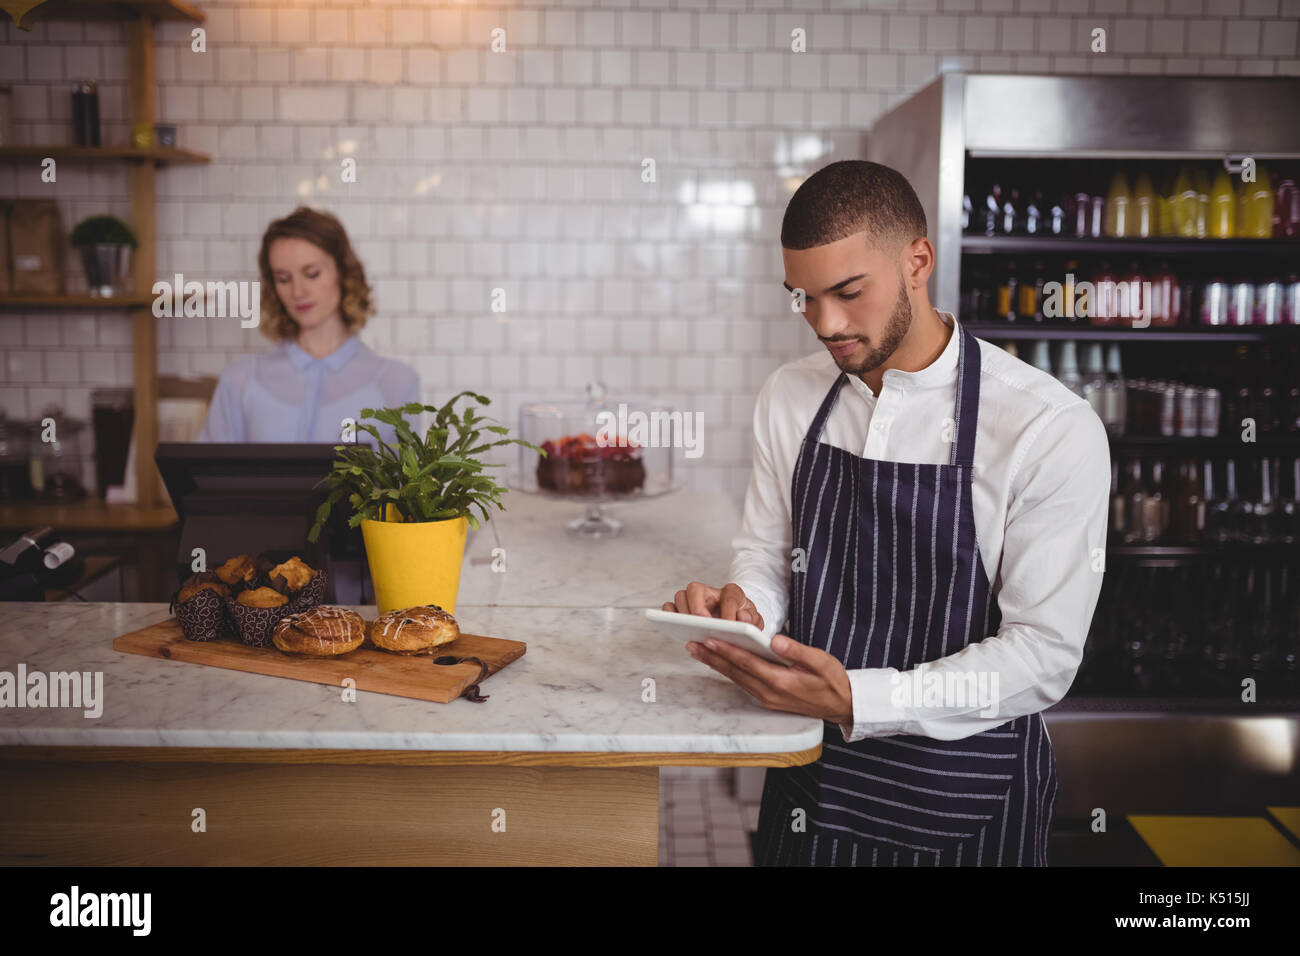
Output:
257,206,374,342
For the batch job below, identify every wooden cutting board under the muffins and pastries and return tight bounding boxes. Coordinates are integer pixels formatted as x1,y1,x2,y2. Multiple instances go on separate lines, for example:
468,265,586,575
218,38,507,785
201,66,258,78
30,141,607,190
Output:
113,618,528,704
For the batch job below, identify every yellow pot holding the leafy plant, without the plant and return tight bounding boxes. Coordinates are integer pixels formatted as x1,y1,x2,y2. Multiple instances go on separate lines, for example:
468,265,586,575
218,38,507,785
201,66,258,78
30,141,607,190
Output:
361,505,469,614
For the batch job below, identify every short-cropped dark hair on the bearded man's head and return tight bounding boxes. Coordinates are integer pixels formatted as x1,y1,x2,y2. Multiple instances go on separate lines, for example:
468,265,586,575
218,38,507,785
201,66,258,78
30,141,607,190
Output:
781,160,926,248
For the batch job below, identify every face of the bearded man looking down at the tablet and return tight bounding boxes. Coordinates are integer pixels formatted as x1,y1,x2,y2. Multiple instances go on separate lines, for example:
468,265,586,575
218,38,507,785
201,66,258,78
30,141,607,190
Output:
781,233,911,375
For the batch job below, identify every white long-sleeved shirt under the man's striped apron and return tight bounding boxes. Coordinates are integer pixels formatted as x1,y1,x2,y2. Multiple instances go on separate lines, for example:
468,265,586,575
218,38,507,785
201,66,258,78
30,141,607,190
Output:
731,312,1110,741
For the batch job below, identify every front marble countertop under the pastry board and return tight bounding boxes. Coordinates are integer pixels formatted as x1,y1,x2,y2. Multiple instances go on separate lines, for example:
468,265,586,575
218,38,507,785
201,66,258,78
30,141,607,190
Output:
0,606,823,753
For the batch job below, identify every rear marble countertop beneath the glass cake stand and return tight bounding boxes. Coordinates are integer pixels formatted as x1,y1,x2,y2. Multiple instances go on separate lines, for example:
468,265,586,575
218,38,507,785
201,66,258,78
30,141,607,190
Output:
456,489,740,608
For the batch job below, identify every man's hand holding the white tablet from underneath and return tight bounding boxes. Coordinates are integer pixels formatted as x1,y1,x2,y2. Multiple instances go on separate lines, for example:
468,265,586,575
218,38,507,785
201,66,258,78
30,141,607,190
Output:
686,633,853,724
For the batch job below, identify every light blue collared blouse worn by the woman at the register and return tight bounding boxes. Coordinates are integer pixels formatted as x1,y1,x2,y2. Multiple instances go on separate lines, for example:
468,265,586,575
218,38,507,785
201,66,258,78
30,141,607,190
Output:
199,336,420,442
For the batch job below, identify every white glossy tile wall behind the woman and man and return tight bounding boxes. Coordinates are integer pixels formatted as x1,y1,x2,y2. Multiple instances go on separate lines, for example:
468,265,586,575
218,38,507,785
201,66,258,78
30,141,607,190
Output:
0,0,1300,498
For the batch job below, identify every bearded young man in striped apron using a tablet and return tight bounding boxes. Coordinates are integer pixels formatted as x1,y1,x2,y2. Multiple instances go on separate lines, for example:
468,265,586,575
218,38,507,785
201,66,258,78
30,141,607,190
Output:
663,161,1110,866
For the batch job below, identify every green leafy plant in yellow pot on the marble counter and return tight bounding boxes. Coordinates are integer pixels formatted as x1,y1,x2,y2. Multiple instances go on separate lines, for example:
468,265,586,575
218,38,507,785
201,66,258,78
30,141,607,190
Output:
307,392,546,614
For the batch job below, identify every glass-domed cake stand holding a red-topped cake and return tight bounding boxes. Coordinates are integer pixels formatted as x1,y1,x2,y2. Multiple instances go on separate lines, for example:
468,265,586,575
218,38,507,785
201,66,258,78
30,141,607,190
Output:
510,381,683,538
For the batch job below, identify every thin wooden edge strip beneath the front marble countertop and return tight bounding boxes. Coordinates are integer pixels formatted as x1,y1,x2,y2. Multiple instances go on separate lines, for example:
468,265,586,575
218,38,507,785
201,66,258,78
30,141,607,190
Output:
0,744,822,767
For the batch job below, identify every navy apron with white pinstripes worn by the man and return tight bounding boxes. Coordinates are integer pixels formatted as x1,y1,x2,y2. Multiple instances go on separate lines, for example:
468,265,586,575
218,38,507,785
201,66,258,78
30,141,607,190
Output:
755,328,1058,866
